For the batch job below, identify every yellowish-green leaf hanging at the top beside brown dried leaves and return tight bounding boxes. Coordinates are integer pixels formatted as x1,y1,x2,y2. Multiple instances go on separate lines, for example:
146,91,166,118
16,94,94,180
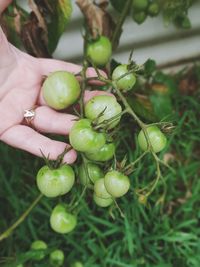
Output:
48,0,72,54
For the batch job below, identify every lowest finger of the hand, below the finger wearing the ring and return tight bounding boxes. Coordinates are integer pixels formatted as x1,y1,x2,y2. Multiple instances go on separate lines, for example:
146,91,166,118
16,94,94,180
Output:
0,125,77,164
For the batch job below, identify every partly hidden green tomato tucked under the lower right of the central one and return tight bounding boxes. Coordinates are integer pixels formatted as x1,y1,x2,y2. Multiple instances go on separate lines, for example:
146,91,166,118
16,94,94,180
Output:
85,143,115,161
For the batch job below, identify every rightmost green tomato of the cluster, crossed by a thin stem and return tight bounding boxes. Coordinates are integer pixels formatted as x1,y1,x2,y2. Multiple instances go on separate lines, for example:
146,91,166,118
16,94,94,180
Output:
138,126,167,153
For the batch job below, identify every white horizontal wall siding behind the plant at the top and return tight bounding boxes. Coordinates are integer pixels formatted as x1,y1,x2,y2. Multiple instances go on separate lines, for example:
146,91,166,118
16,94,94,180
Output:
54,1,200,67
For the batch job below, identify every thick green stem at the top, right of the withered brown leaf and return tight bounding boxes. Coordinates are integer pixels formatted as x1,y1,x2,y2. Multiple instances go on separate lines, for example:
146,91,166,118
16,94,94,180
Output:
111,0,132,49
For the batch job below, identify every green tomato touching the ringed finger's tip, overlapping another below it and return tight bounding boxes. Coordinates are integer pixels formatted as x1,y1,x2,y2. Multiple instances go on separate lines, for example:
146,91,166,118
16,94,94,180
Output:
69,119,106,152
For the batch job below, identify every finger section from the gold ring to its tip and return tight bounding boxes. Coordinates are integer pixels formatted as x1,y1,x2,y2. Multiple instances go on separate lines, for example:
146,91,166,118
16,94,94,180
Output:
32,106,77,135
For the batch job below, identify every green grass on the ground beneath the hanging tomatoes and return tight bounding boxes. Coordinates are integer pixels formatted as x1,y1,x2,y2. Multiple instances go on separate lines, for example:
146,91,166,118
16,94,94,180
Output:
0,68,200,267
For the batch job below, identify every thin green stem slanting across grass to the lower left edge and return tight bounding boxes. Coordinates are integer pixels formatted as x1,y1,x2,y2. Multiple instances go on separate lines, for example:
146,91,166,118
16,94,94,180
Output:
0,194,43,241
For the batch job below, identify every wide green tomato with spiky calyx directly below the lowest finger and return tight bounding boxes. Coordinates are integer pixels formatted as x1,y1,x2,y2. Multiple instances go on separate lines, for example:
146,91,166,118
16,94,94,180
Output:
36,164,75,197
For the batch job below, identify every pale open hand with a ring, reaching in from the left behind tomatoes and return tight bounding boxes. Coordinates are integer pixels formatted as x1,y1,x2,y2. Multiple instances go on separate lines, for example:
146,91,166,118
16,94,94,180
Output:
0,0,108,163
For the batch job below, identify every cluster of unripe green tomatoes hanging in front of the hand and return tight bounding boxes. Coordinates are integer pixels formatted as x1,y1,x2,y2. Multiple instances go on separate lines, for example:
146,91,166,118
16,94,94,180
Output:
37,36,166,238
